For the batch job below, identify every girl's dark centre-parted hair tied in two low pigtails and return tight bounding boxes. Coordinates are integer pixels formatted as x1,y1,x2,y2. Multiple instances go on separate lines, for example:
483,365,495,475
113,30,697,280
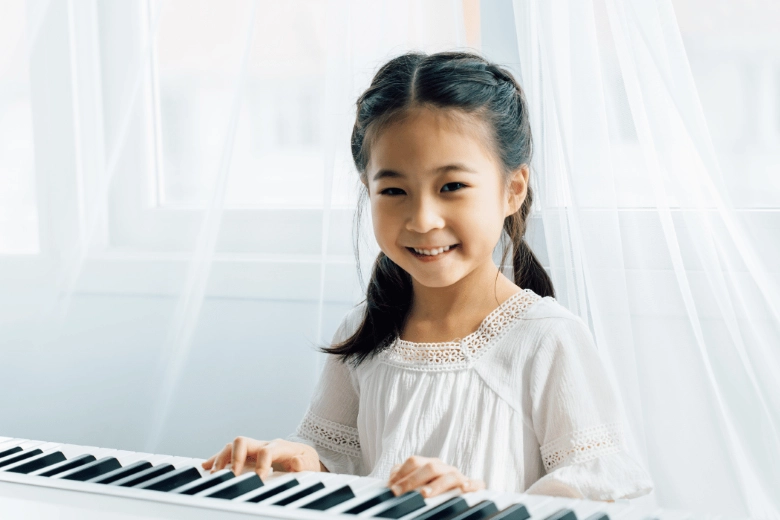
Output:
322,52,555,366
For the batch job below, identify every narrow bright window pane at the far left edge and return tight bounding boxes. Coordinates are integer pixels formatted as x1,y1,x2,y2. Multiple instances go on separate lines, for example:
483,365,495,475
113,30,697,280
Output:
0,0,39,254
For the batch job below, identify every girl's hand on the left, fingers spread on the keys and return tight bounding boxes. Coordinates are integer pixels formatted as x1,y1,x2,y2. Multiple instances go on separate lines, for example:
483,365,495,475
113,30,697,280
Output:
202,437,320,480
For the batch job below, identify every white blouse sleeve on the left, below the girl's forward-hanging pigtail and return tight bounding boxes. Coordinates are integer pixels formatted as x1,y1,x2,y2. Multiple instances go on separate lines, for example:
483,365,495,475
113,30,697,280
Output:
289,310,362,475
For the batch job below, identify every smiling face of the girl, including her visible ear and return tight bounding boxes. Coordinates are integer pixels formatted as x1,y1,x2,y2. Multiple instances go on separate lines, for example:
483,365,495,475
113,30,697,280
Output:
366,108,528,288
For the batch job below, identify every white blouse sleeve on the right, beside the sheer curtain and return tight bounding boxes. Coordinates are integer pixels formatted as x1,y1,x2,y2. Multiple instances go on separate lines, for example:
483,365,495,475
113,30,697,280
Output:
526,318,653,500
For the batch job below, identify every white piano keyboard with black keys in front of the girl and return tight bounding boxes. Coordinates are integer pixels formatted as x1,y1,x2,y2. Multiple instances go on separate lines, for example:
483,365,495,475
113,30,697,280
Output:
0,437,702,520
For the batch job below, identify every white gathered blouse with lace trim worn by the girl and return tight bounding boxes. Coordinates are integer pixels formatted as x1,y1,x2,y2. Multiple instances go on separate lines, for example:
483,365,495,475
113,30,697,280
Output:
290,289,653,500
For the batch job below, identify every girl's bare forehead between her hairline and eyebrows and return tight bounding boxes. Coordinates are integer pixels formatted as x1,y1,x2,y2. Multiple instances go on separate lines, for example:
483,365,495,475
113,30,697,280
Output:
367,107,496,172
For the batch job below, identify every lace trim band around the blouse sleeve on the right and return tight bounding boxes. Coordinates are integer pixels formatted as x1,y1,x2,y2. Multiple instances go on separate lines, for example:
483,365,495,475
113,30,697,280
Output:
540,422,623,472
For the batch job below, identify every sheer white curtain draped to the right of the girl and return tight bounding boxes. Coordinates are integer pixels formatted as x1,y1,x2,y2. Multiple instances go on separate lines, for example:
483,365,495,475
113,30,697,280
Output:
502,0,780,518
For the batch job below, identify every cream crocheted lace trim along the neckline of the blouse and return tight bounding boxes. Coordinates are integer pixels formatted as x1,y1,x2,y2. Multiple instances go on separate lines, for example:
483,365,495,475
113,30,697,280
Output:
382,289,554,371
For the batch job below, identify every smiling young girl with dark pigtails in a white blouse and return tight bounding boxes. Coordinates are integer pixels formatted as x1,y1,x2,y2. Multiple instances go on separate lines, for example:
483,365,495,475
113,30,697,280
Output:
203,53,652,500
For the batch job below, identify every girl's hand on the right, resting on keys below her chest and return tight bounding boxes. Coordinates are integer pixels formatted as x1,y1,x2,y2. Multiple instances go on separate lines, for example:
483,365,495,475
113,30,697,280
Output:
388,456,485,498
